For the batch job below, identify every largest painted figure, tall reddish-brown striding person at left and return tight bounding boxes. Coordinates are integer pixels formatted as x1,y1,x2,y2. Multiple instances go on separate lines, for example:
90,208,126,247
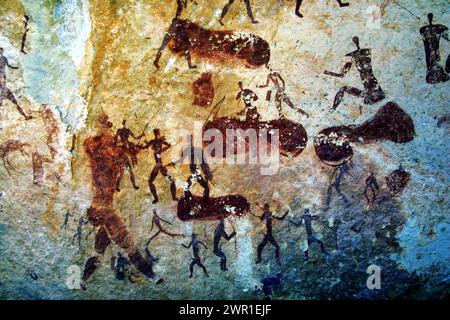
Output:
82,114,159,288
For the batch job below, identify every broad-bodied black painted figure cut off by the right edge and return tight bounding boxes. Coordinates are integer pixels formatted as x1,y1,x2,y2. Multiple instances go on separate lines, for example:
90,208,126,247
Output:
420,13,450,84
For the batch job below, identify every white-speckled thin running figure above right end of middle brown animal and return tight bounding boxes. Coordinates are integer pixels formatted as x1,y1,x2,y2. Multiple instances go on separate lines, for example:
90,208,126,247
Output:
256,64,309,119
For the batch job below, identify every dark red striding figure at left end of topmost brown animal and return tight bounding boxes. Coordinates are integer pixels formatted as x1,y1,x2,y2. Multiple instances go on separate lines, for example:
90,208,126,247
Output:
153,0,197,69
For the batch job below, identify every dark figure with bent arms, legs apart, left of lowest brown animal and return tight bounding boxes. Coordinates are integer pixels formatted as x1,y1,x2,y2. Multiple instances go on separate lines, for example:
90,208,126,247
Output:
144,129,178,203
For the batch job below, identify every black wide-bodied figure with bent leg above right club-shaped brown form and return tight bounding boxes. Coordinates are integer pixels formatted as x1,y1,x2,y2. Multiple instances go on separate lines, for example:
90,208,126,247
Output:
325,37,385,110
